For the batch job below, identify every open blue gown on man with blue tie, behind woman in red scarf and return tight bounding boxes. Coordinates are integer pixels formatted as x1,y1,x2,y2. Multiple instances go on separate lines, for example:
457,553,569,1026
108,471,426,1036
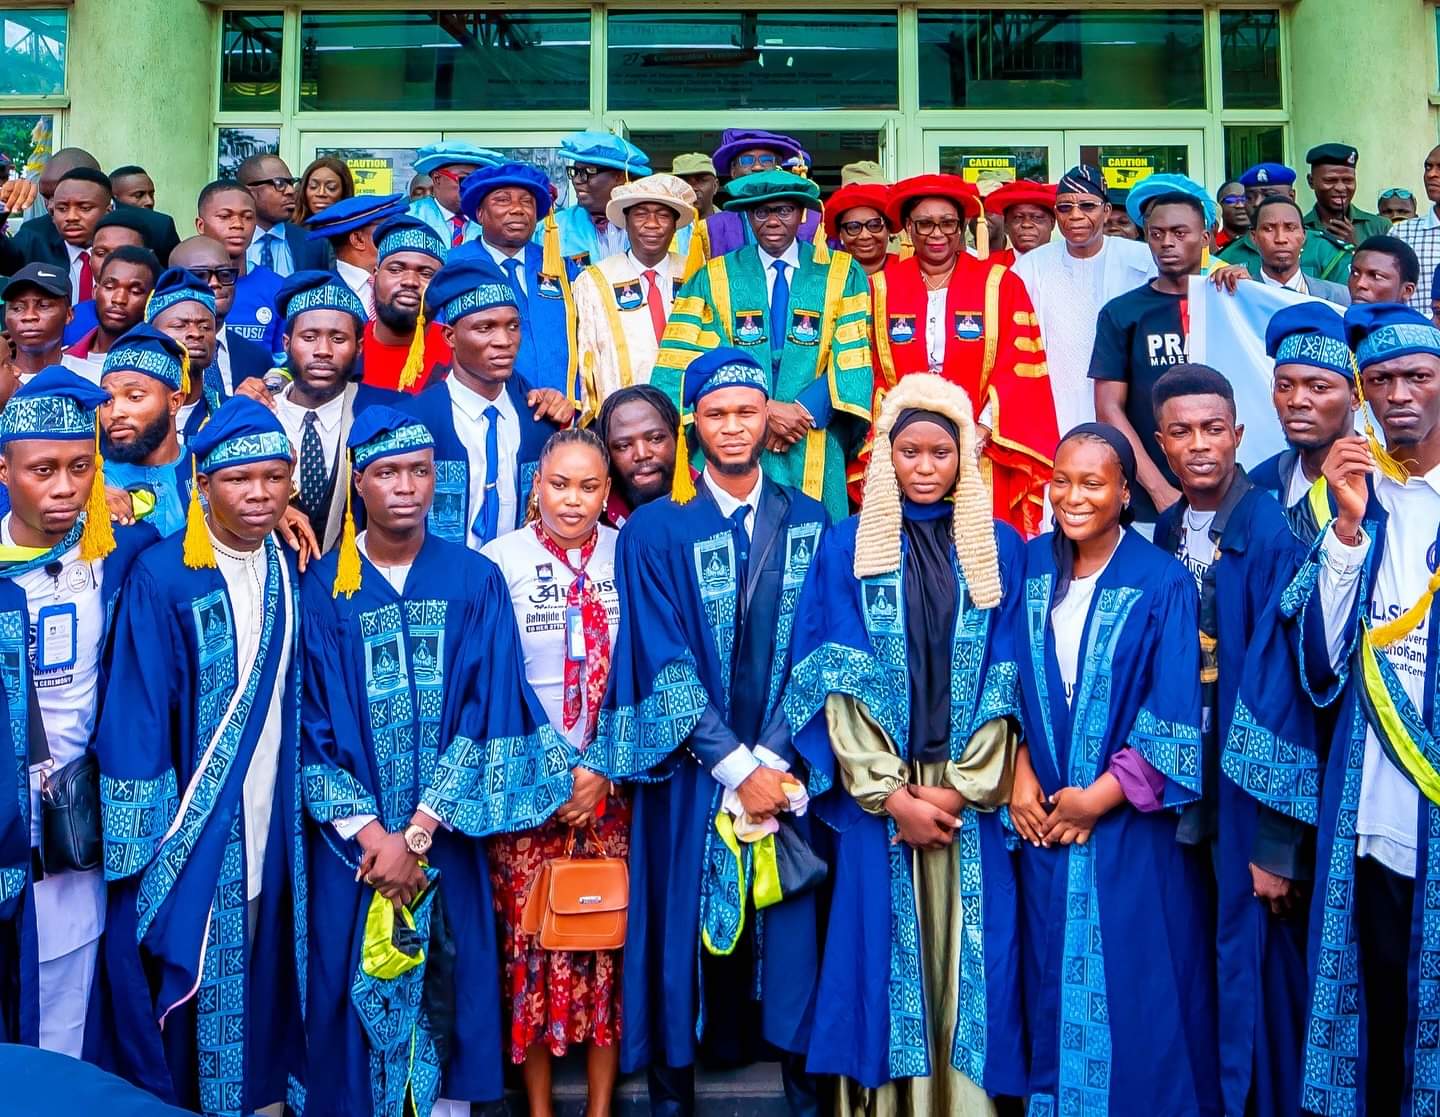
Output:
408,376,560,546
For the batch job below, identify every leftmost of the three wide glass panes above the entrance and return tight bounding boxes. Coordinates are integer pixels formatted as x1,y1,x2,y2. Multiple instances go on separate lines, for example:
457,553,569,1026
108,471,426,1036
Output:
300,10,590,112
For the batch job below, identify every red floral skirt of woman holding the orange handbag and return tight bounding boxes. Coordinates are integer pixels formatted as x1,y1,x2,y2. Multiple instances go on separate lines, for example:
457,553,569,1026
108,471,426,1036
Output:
487,796,629,1064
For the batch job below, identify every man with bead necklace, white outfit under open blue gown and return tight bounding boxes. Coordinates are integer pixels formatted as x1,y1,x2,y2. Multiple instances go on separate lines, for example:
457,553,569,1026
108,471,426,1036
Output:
89,397,307,1117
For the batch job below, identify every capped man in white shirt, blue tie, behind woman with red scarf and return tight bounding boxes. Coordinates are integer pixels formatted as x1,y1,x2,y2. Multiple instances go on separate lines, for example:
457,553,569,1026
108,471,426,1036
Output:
397,255,573,550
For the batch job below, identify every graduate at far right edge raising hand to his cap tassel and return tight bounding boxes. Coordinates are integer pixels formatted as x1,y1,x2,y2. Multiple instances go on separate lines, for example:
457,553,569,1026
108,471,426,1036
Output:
1261,304,1440,1117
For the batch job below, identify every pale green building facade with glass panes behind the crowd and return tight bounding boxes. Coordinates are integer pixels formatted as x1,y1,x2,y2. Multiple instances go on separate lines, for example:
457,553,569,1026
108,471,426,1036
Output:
0,0,1440,223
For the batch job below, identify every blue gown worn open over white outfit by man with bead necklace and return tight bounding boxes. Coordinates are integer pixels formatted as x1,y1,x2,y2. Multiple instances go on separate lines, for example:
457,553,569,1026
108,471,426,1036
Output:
86,534,307,1117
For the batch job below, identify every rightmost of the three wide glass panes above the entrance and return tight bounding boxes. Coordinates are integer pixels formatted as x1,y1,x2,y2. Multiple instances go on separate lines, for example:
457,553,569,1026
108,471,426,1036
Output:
920,10,1205,109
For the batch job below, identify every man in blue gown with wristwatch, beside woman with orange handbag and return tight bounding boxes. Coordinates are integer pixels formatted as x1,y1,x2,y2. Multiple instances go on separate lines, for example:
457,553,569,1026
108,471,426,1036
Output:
301,406,569,1117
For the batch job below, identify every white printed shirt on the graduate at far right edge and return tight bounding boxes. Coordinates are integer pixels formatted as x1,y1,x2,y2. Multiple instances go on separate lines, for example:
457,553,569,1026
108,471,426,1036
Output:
1318,466,1440,877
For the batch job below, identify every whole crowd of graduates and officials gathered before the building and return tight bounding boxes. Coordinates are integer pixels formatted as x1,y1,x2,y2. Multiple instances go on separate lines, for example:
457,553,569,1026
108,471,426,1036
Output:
0,122,1440,1117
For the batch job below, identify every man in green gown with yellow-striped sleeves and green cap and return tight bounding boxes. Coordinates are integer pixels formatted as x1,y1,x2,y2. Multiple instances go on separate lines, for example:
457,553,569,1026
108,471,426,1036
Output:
651,170,874,520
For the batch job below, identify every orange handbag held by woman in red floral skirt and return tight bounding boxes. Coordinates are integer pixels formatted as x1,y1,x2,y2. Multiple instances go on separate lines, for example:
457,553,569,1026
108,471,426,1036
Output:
520,831,629,950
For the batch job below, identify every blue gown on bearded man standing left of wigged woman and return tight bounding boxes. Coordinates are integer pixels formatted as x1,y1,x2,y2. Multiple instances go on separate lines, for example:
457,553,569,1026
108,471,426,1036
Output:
583,479,825,1072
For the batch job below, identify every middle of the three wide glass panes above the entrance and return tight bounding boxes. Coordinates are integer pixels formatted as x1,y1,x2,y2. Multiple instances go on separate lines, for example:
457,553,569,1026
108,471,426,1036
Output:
606,12,899,109
